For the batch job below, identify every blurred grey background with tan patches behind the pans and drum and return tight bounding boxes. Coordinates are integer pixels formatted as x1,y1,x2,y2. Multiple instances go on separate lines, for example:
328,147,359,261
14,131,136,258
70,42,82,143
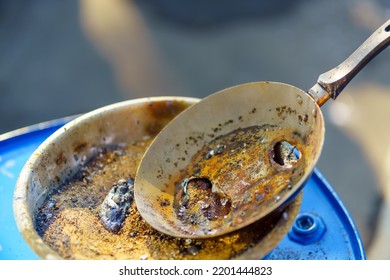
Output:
0,0,390,259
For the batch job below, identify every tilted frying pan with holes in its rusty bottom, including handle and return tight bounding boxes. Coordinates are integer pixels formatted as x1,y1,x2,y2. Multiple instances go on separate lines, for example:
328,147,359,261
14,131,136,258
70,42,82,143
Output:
135,20,390,238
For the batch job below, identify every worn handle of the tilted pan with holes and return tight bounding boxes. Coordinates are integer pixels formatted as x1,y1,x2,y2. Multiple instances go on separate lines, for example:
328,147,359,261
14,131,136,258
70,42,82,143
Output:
308,20,390,106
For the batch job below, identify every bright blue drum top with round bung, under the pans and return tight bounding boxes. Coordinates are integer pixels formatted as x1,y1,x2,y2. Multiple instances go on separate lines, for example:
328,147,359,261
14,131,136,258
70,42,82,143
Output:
0,117,365,260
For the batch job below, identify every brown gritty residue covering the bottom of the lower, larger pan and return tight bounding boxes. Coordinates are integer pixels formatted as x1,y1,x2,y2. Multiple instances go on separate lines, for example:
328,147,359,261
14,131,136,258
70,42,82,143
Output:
35,139,296,260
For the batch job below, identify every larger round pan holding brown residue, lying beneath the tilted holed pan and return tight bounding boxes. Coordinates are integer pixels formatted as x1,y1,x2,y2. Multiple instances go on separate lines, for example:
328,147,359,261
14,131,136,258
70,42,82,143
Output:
14,97,301,259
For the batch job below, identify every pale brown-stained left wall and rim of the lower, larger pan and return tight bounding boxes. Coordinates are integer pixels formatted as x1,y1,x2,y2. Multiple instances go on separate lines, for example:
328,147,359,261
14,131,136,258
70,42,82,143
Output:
14,97,198,259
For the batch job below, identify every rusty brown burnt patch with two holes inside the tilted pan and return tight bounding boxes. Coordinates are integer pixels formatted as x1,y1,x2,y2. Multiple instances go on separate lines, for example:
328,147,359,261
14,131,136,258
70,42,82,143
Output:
171,124,306,235
